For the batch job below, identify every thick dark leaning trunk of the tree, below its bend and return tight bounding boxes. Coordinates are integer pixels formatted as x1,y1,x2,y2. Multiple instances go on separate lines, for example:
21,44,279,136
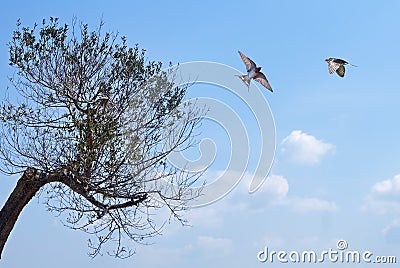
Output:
0,168,48,259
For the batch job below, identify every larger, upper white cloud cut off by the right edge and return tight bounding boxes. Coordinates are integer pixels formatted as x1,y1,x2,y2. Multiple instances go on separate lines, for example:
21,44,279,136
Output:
362,174,400,214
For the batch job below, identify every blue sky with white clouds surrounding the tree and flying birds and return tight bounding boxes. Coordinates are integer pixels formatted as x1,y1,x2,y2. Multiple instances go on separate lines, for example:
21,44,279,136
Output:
0,0,400,268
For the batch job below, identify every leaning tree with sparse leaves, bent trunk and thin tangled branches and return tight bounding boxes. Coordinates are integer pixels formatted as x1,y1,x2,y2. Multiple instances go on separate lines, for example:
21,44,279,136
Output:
0,18,203,257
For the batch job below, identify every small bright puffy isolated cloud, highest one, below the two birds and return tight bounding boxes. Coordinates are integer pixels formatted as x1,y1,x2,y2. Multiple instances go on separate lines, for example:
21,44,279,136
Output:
281,130,335,164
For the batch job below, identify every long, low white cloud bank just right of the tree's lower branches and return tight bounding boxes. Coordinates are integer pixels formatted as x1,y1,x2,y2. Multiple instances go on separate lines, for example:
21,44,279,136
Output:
186,171,337,229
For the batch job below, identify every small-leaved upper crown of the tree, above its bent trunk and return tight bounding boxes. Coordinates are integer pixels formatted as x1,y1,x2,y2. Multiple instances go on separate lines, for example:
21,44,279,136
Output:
1,18,184,177
